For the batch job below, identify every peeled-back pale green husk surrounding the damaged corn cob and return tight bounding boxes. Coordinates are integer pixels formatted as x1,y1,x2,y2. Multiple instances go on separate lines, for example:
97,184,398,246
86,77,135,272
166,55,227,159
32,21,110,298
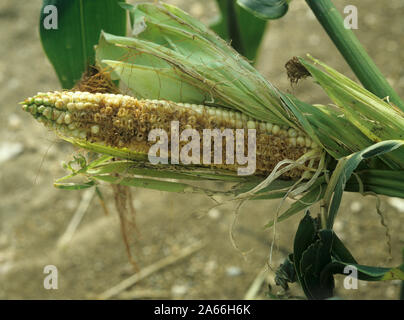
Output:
21,3,404,226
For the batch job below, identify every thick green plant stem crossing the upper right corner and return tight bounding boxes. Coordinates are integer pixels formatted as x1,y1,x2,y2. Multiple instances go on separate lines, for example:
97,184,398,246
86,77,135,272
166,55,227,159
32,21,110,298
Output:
306,0,404,111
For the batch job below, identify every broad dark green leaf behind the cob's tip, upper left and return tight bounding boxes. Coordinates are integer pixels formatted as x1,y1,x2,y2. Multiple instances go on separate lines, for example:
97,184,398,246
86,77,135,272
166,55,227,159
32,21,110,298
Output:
39,0,126,89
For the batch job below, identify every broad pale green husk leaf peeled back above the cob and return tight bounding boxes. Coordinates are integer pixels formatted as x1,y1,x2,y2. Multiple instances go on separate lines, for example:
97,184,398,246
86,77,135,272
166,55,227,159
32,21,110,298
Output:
96,3,296,127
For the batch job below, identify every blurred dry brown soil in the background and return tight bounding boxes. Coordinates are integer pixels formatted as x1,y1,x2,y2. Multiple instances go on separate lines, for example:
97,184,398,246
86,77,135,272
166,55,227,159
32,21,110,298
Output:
0,0,404,299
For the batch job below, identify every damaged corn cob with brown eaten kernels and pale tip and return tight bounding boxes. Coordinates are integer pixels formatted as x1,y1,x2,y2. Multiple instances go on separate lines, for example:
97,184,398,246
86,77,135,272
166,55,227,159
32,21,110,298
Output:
23,91,317,178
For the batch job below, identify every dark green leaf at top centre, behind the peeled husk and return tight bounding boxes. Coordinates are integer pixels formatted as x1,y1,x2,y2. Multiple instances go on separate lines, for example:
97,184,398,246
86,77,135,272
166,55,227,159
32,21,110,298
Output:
210,0,267,61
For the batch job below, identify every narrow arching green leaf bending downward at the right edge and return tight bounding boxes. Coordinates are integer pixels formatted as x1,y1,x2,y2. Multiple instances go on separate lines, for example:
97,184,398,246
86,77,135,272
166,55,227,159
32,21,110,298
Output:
324,140,404,229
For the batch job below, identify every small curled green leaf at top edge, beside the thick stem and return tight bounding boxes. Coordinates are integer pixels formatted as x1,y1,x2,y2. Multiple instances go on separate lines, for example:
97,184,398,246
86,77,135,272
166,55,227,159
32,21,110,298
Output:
237,0,289,20
